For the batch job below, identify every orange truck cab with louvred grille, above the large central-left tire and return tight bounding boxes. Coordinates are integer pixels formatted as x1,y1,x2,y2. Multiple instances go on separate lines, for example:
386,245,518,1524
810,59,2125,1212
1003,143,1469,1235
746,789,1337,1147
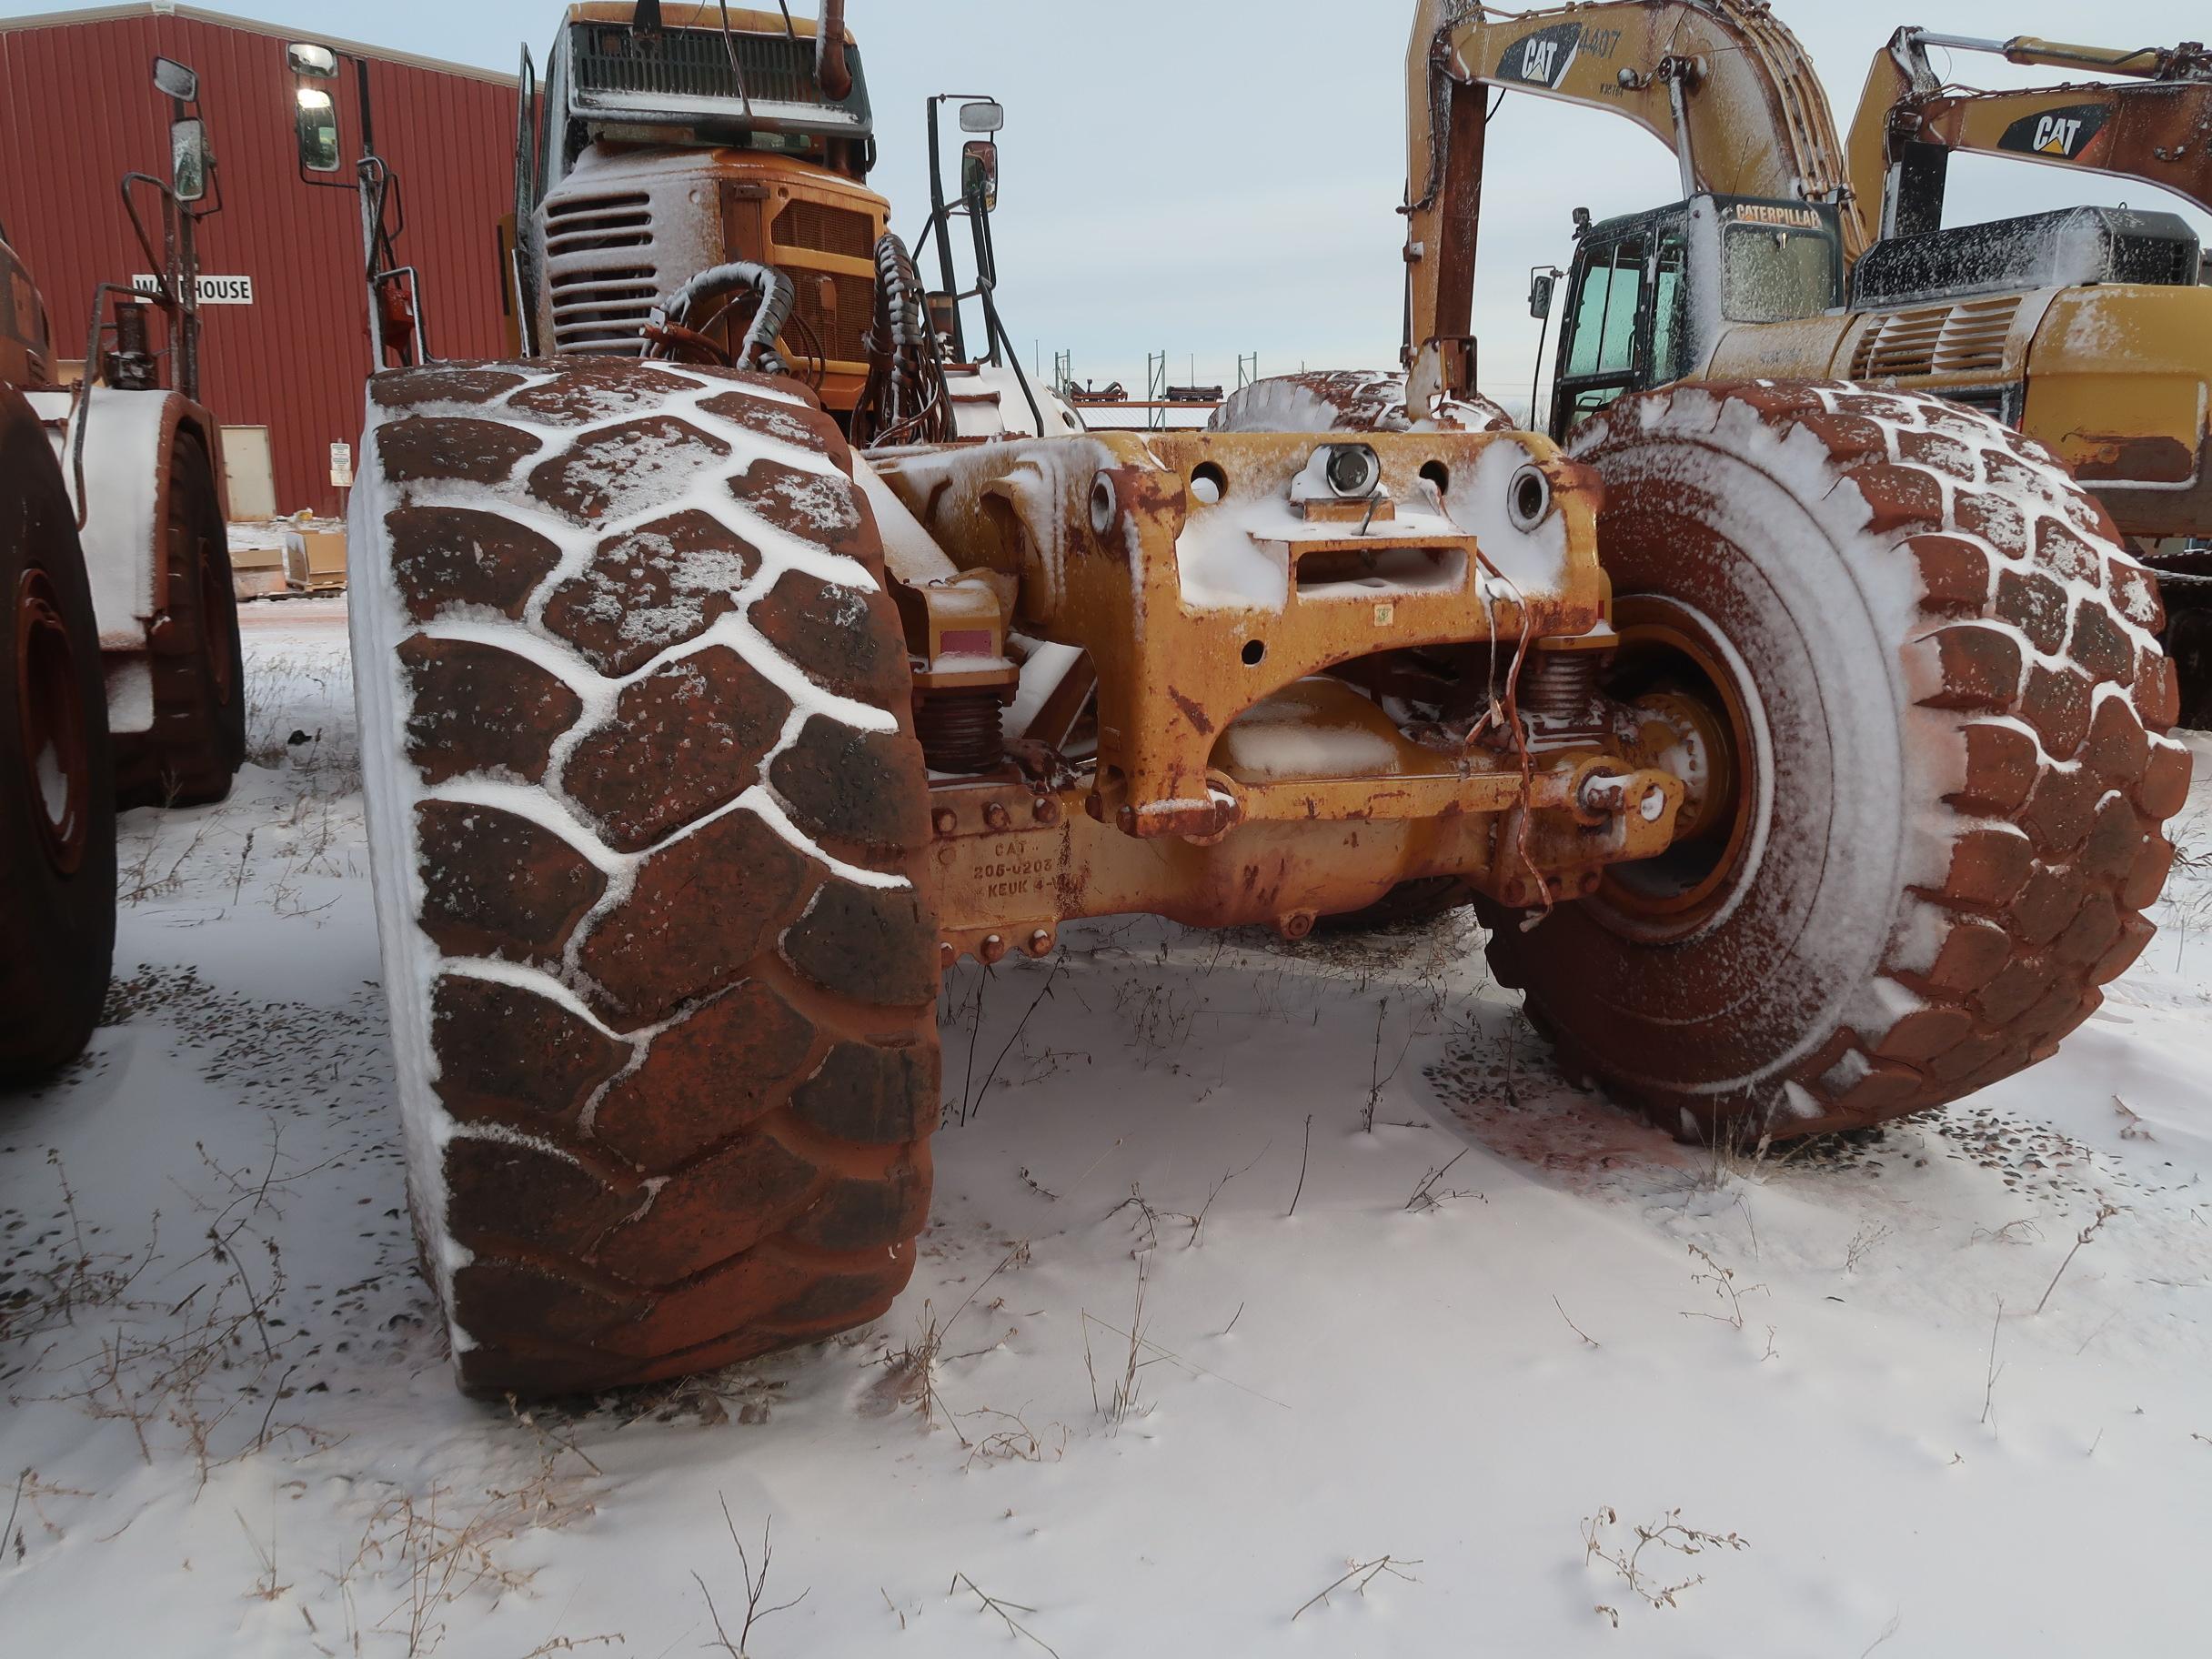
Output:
513,0,890,411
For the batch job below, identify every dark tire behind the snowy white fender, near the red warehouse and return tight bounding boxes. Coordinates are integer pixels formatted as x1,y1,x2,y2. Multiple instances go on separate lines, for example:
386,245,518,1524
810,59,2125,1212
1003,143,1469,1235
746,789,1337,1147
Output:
115,431,246,808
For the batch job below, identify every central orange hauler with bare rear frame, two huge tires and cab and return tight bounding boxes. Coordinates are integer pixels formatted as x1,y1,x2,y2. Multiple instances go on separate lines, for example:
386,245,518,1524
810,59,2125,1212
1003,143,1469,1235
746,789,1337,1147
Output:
352,6,2186,1393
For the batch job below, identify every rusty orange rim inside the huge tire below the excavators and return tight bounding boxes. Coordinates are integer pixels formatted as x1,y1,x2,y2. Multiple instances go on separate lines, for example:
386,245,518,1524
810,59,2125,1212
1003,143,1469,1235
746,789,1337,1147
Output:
1593,595,1761,942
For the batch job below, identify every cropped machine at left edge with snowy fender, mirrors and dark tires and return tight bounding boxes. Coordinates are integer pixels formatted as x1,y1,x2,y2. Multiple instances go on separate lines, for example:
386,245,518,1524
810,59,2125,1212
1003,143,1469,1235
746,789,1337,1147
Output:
0,60,246,1077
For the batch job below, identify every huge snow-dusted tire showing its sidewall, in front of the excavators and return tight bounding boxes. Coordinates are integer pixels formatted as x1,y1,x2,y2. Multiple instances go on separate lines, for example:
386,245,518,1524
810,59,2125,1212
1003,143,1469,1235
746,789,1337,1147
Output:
1489,385,2190,1139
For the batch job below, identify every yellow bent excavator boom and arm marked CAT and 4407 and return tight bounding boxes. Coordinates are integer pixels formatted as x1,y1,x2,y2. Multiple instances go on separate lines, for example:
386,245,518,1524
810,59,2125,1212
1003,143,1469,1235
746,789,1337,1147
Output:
1407,0,1865,400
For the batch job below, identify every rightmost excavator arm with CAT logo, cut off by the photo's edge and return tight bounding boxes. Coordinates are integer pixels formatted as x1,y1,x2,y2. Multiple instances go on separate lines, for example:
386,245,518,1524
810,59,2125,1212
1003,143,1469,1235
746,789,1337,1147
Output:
1849,29,2212,243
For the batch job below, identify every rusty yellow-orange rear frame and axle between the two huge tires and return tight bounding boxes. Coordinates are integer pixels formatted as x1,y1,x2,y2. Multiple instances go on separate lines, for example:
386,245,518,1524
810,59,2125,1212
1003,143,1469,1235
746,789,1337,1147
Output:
876,434,1684,960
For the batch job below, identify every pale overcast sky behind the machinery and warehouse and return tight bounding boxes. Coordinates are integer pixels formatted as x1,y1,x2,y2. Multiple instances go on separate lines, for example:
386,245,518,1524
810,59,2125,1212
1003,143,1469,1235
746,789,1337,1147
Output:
0,0,2212,403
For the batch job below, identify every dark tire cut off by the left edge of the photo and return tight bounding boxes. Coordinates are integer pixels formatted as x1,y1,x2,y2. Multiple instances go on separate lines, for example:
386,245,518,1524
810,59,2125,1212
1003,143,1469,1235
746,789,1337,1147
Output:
0,387,115,1084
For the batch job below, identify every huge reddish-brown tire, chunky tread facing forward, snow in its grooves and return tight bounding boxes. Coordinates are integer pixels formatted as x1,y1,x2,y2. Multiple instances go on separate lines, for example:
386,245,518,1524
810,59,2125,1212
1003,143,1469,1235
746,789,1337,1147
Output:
352,360,938,1393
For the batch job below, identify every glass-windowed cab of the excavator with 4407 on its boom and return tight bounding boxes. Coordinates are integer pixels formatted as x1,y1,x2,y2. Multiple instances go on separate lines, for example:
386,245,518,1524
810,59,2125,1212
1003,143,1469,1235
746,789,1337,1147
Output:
1548,195,1845,440
